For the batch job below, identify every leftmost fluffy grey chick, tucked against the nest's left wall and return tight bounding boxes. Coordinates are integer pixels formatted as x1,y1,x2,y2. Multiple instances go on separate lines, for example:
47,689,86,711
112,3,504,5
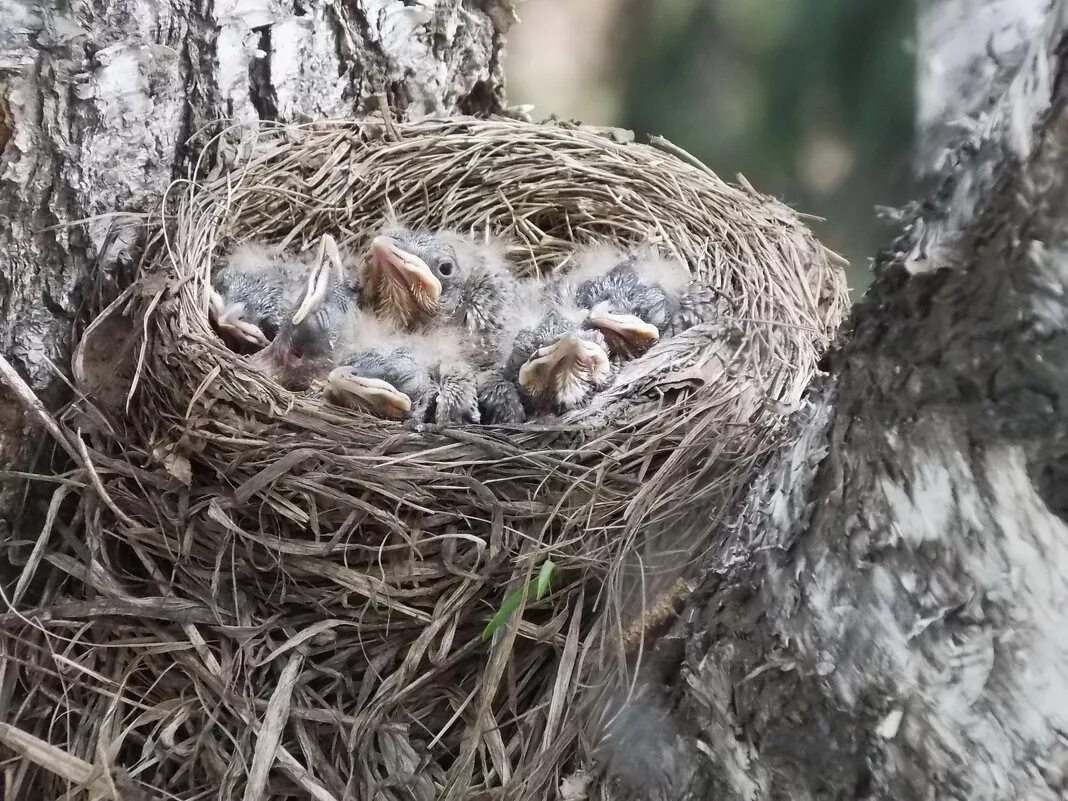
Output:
208,242,309,349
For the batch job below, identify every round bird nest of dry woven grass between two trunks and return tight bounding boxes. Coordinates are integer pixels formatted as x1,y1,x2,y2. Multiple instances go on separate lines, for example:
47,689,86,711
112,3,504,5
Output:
5,119,846,801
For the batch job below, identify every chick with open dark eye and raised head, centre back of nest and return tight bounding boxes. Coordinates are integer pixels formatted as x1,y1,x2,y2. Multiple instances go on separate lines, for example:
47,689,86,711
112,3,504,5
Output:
360,227,516,347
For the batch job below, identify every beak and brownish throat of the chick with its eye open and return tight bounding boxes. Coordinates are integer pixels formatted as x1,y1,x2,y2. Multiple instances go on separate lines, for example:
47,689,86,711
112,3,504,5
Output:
370,236,441,326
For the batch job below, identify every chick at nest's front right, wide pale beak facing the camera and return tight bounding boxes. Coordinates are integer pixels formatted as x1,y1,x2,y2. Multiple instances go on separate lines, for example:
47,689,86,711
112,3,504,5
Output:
504,281,615,415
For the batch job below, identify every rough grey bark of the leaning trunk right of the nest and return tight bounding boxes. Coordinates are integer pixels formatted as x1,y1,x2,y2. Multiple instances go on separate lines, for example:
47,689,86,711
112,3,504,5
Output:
624,0,1068,801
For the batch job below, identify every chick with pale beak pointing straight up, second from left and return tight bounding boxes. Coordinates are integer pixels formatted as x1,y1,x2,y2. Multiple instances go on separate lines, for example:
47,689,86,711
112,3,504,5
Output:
249,234,354,390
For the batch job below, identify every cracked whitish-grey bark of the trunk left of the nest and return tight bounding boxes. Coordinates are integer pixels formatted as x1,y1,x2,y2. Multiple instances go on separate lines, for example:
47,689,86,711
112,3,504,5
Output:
0,0,513,527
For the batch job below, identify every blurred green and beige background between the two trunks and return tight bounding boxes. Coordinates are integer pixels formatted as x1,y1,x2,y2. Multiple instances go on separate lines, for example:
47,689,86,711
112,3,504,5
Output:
506,0,916,296
